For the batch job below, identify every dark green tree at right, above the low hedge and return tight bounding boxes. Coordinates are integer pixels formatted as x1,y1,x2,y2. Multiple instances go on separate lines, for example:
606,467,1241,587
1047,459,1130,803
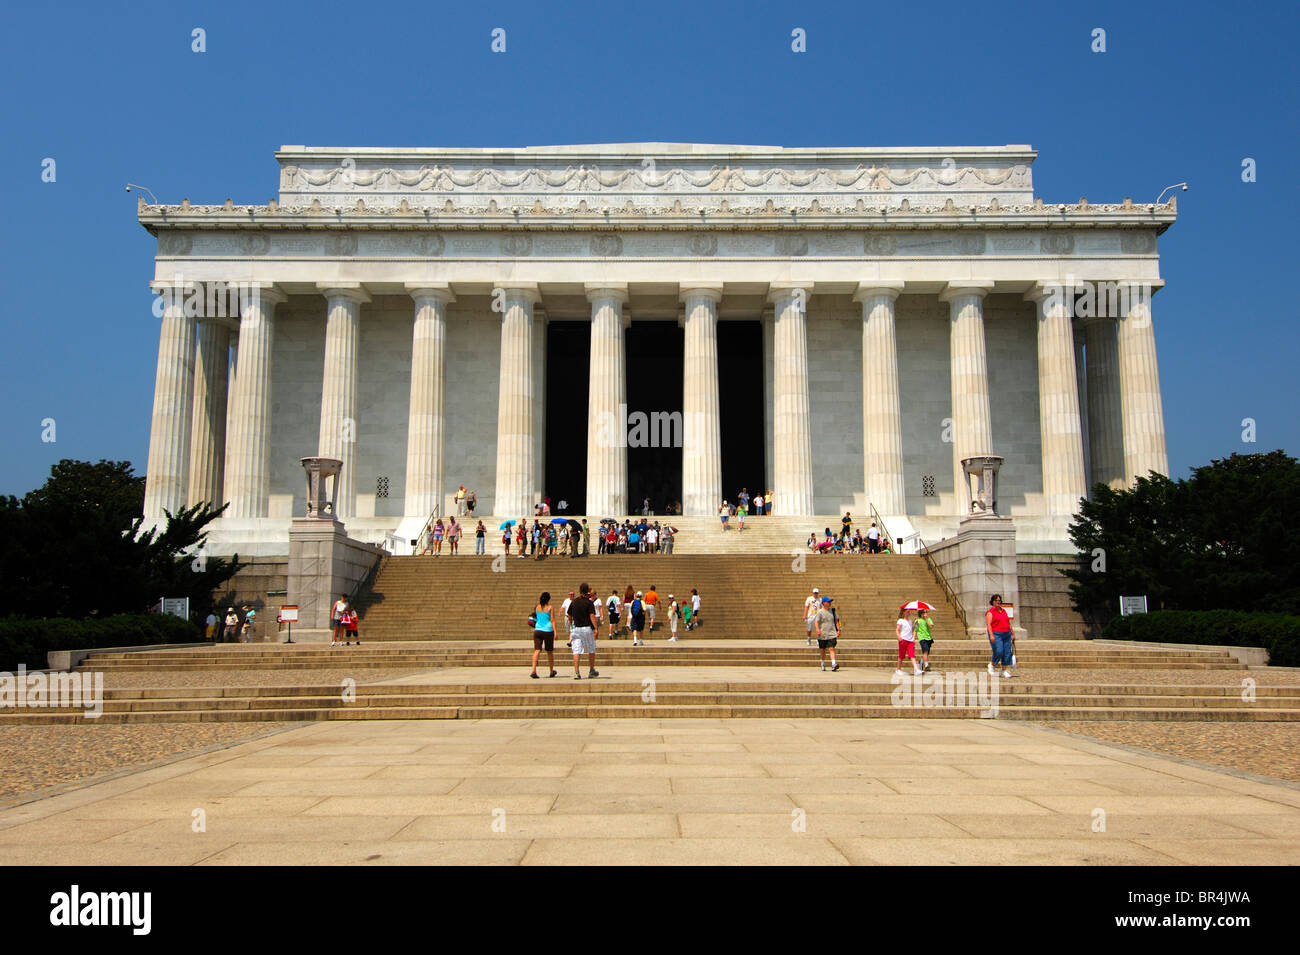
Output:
1063,451,1300,628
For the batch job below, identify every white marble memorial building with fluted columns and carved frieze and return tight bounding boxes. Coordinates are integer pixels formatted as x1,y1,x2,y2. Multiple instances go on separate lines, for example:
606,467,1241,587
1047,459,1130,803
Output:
139,143,1177,555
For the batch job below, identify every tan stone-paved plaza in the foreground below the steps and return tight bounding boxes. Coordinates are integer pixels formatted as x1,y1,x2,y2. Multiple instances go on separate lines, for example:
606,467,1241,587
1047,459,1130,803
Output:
0,720,1300,865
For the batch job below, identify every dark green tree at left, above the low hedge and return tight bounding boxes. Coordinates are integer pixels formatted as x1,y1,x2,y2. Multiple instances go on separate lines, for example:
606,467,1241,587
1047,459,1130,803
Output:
0,460,239,617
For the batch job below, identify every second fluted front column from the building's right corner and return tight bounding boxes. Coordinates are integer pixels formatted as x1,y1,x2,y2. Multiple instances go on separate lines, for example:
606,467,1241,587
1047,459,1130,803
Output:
1024,283,1088,517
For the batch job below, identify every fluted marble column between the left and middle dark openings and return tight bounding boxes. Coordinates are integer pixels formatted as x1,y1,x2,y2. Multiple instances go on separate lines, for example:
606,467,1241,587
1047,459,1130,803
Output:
586,285,628,520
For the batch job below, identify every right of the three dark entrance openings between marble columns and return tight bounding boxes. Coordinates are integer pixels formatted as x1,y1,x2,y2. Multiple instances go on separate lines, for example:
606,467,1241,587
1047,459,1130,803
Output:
714,321,767,507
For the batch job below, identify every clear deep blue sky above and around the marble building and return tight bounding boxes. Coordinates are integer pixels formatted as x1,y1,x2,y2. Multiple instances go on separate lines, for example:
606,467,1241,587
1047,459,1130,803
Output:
0,0,1300,494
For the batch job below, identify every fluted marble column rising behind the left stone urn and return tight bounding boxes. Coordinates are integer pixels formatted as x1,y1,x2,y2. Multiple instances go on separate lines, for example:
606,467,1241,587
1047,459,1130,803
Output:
316,282,371,520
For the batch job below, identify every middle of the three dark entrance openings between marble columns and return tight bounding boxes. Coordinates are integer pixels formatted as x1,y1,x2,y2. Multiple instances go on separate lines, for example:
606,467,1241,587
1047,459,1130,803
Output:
626,321,685,517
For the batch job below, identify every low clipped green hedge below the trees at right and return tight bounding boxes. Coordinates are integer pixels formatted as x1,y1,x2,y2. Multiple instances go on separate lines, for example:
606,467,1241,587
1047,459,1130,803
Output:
1101,611,1300,667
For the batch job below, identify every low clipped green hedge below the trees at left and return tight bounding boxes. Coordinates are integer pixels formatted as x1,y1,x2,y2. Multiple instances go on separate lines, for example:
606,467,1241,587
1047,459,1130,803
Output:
0,613,202,672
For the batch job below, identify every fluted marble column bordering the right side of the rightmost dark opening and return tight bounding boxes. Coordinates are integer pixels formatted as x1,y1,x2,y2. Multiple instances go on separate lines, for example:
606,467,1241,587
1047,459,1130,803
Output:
768,282,813,517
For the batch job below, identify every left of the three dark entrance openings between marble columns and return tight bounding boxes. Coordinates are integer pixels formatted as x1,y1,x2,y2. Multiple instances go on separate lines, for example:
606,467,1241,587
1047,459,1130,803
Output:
546,322,592,515
